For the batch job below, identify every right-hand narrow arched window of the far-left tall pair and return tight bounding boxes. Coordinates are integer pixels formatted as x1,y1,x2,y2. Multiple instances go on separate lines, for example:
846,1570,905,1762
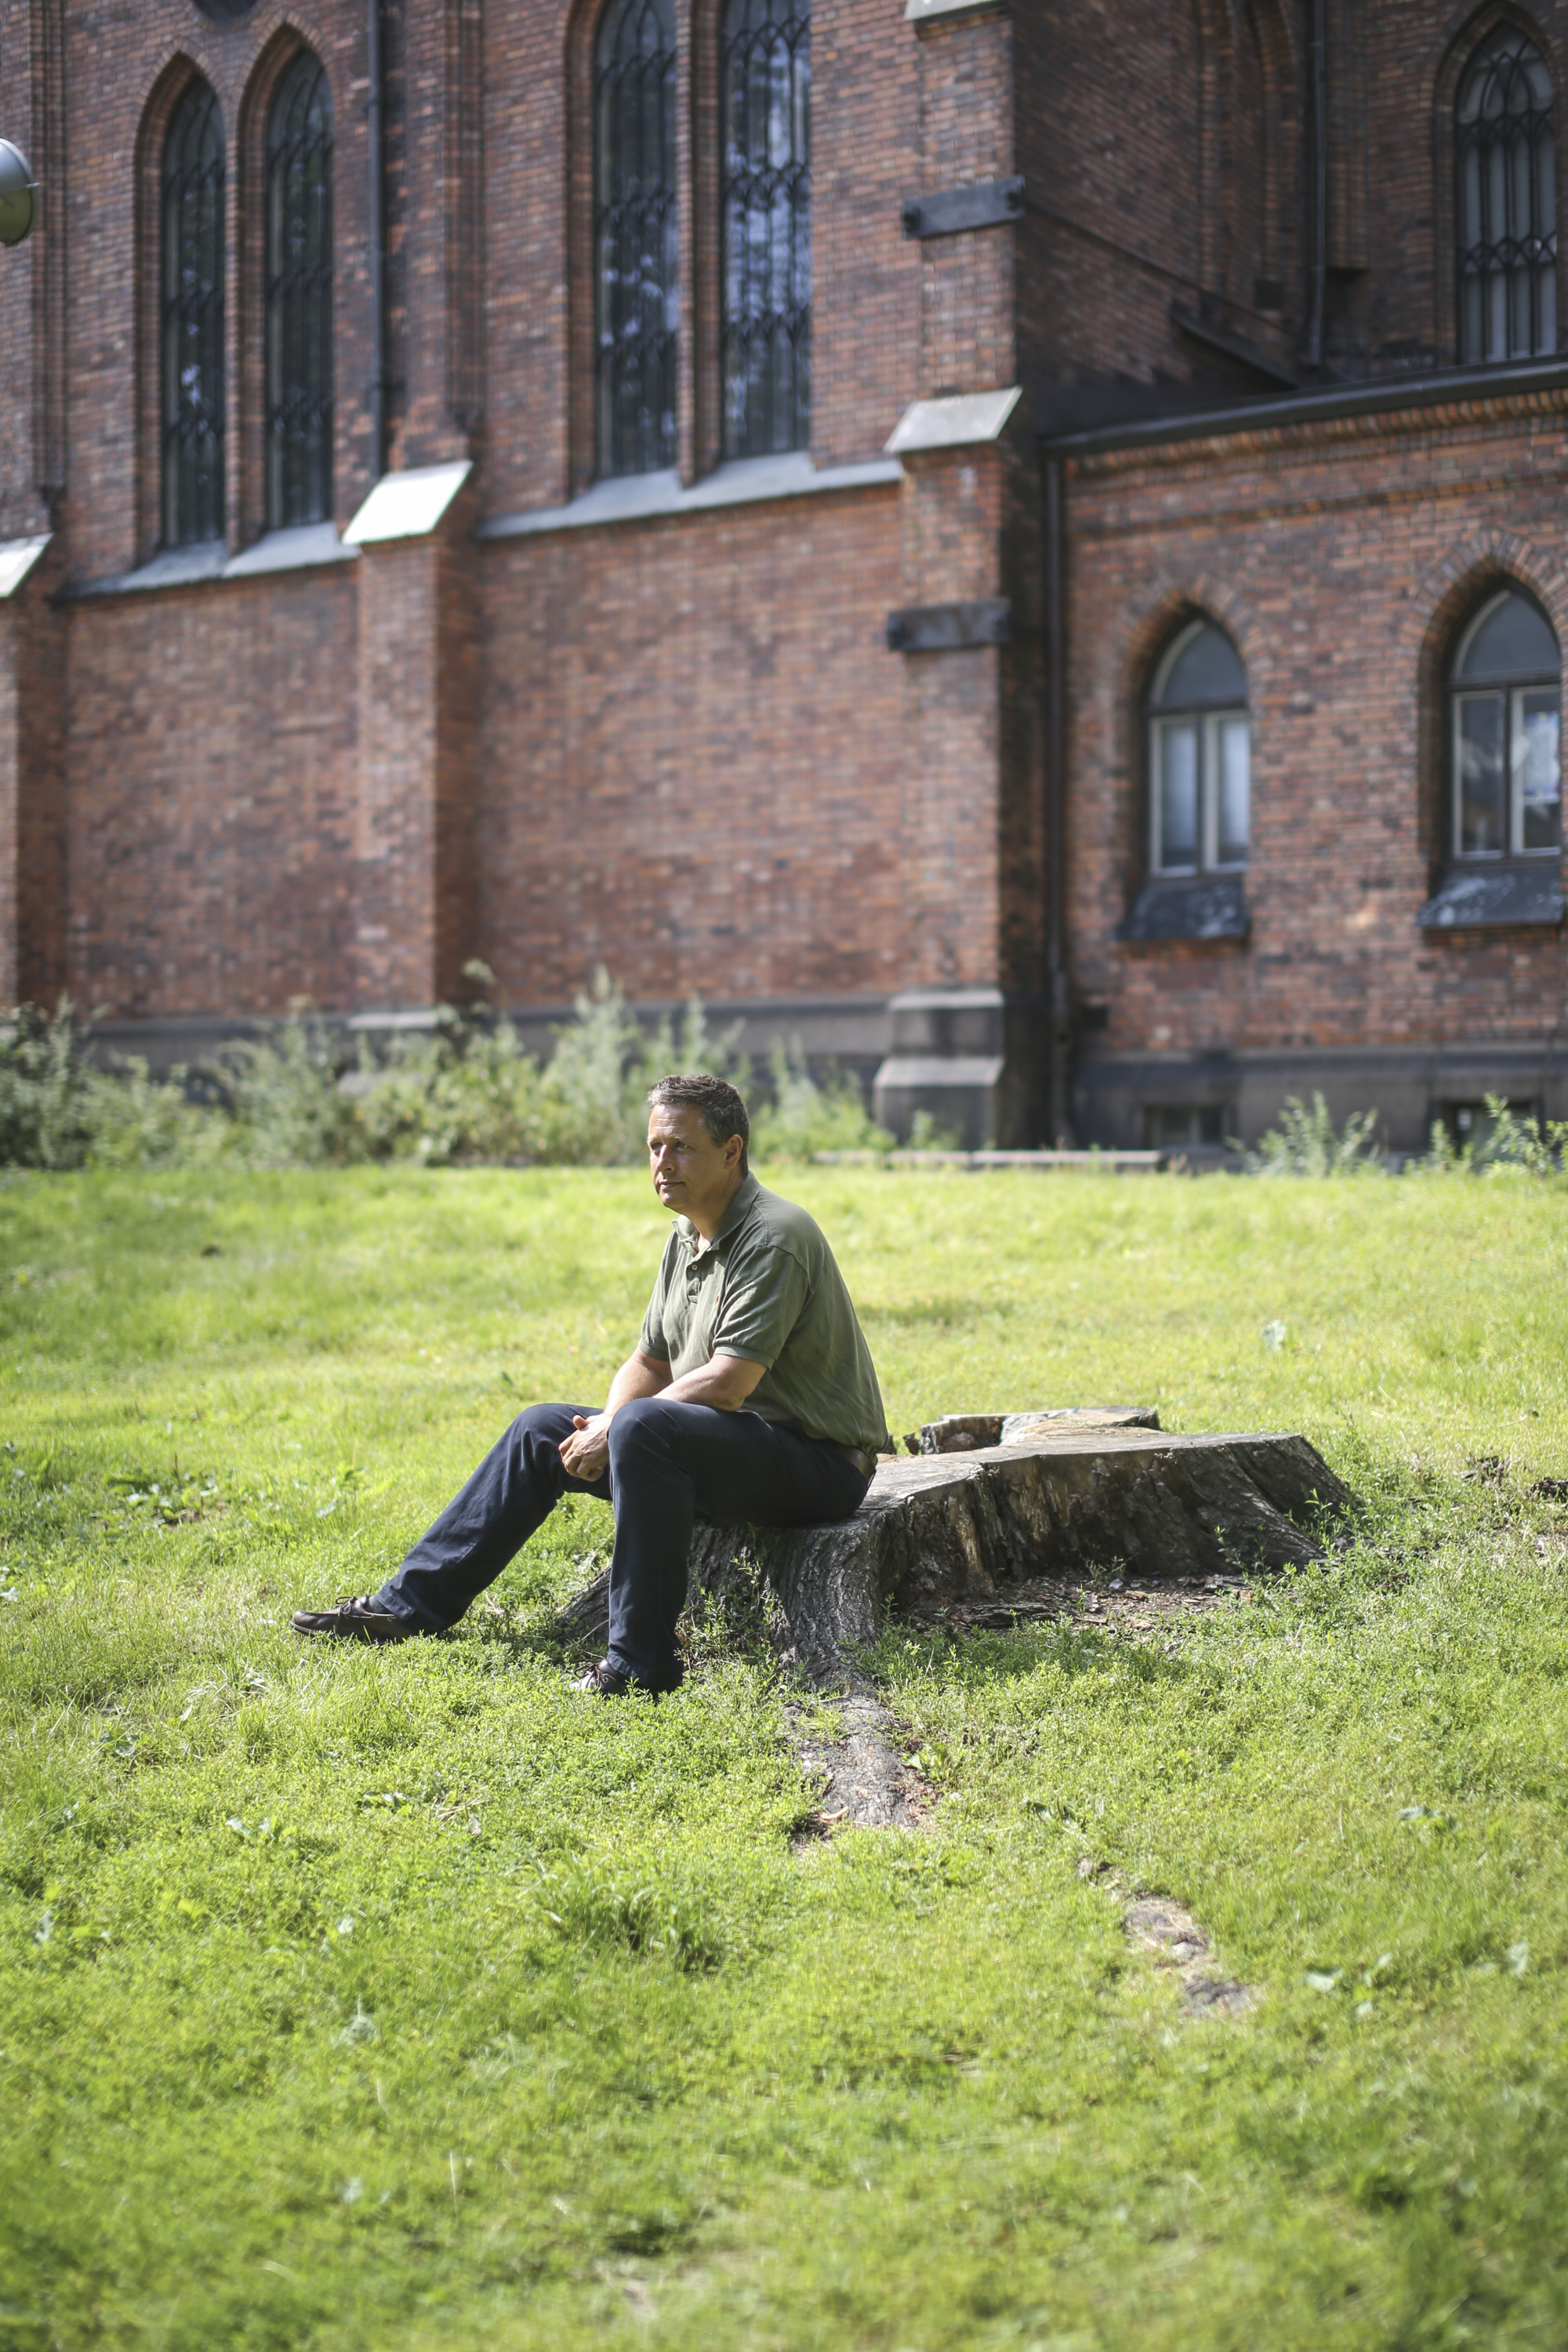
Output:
266,49,332,532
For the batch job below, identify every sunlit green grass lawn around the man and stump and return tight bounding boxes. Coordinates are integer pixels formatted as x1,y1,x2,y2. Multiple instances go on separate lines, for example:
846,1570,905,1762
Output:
0,1169,1568,2352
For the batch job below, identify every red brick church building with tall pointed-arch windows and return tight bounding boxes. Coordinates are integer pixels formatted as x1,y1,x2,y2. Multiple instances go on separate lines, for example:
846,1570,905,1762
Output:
0,0,1568,1148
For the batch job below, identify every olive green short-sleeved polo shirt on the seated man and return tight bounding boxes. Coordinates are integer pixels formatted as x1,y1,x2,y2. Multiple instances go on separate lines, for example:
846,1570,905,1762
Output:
637,1176,891,1454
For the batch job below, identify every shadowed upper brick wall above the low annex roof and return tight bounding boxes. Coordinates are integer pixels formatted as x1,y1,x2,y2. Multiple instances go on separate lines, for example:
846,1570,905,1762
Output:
1006,0,1568,421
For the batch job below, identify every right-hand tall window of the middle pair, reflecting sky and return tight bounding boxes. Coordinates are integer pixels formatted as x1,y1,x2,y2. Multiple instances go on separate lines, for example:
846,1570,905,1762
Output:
722,0,811,456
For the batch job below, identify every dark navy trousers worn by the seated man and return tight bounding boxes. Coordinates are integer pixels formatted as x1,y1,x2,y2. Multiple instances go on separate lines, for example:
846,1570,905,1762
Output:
376,1397,867,1691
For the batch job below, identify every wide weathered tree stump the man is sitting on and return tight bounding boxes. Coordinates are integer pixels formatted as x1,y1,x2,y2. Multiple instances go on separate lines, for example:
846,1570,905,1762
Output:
560,1406,1354,1677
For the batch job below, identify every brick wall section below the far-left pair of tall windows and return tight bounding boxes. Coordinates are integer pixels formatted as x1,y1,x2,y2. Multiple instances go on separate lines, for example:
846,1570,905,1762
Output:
66,564,358,1016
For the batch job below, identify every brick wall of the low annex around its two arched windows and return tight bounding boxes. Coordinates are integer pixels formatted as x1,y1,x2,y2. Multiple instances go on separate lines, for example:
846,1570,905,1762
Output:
1067,397,1568,1054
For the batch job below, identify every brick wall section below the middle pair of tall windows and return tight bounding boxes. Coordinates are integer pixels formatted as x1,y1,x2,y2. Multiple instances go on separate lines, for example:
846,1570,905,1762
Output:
477,489,907,1004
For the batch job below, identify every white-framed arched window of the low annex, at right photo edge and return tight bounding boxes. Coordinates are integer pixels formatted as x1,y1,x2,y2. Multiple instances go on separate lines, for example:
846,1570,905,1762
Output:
1450,588,1563,858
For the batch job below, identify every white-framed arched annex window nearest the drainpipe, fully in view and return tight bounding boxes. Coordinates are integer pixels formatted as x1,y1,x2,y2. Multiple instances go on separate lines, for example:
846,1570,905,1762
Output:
1149,621,1250,875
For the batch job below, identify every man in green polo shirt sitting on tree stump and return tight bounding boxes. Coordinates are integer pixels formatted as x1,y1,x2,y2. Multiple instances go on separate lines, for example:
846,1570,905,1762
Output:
294,1073,891,1698
